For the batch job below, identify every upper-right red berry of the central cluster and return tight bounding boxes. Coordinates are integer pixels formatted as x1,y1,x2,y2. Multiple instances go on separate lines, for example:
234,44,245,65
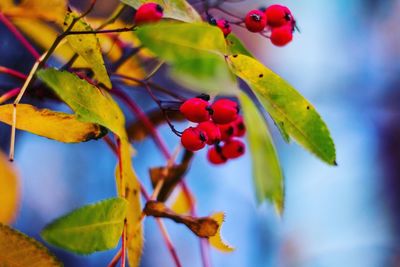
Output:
211,99,239,124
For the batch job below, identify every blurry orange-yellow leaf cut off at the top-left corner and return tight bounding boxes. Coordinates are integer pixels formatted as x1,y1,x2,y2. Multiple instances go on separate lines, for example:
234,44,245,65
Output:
2,0,67,25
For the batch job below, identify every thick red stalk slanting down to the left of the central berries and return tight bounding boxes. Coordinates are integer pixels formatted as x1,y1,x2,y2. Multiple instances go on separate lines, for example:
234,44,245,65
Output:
110,88,170,158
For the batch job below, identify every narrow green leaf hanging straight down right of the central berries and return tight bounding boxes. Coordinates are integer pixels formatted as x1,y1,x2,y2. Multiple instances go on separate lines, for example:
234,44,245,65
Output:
239,93,284,213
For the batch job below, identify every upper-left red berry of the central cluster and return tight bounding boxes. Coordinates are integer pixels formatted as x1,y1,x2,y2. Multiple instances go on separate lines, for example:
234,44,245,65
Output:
179,97,210,122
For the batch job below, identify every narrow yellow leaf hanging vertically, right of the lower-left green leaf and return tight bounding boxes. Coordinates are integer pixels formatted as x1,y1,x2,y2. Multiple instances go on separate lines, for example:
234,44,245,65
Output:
115,139,143,267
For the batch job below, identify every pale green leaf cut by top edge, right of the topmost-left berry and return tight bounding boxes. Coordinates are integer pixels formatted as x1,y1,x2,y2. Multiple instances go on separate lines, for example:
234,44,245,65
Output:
121,0,201,22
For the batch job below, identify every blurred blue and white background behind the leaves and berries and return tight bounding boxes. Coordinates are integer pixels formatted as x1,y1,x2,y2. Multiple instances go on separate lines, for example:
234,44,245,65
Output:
0,0,400,267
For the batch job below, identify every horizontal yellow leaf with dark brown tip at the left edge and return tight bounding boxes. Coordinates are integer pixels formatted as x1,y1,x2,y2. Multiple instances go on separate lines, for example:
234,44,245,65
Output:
0,104,107,143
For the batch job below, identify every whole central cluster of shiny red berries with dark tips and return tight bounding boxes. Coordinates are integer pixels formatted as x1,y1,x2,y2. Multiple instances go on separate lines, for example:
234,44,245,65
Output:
180,96,246,164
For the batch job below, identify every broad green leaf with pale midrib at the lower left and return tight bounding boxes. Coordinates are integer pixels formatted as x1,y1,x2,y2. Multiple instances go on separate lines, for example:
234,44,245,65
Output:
41,198,127,254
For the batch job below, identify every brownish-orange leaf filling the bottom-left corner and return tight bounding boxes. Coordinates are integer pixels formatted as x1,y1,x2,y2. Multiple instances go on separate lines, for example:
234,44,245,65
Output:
0,223,62,267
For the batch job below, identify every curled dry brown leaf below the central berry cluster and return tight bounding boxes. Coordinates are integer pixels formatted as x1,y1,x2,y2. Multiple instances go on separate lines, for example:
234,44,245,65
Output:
144,201,220,238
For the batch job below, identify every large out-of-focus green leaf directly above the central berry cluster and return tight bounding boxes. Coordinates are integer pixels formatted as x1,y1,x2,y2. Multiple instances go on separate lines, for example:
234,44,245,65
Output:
137,22,237,94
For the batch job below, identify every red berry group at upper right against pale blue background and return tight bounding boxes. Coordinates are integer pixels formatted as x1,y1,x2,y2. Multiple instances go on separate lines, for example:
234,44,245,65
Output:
209,5,296,46
